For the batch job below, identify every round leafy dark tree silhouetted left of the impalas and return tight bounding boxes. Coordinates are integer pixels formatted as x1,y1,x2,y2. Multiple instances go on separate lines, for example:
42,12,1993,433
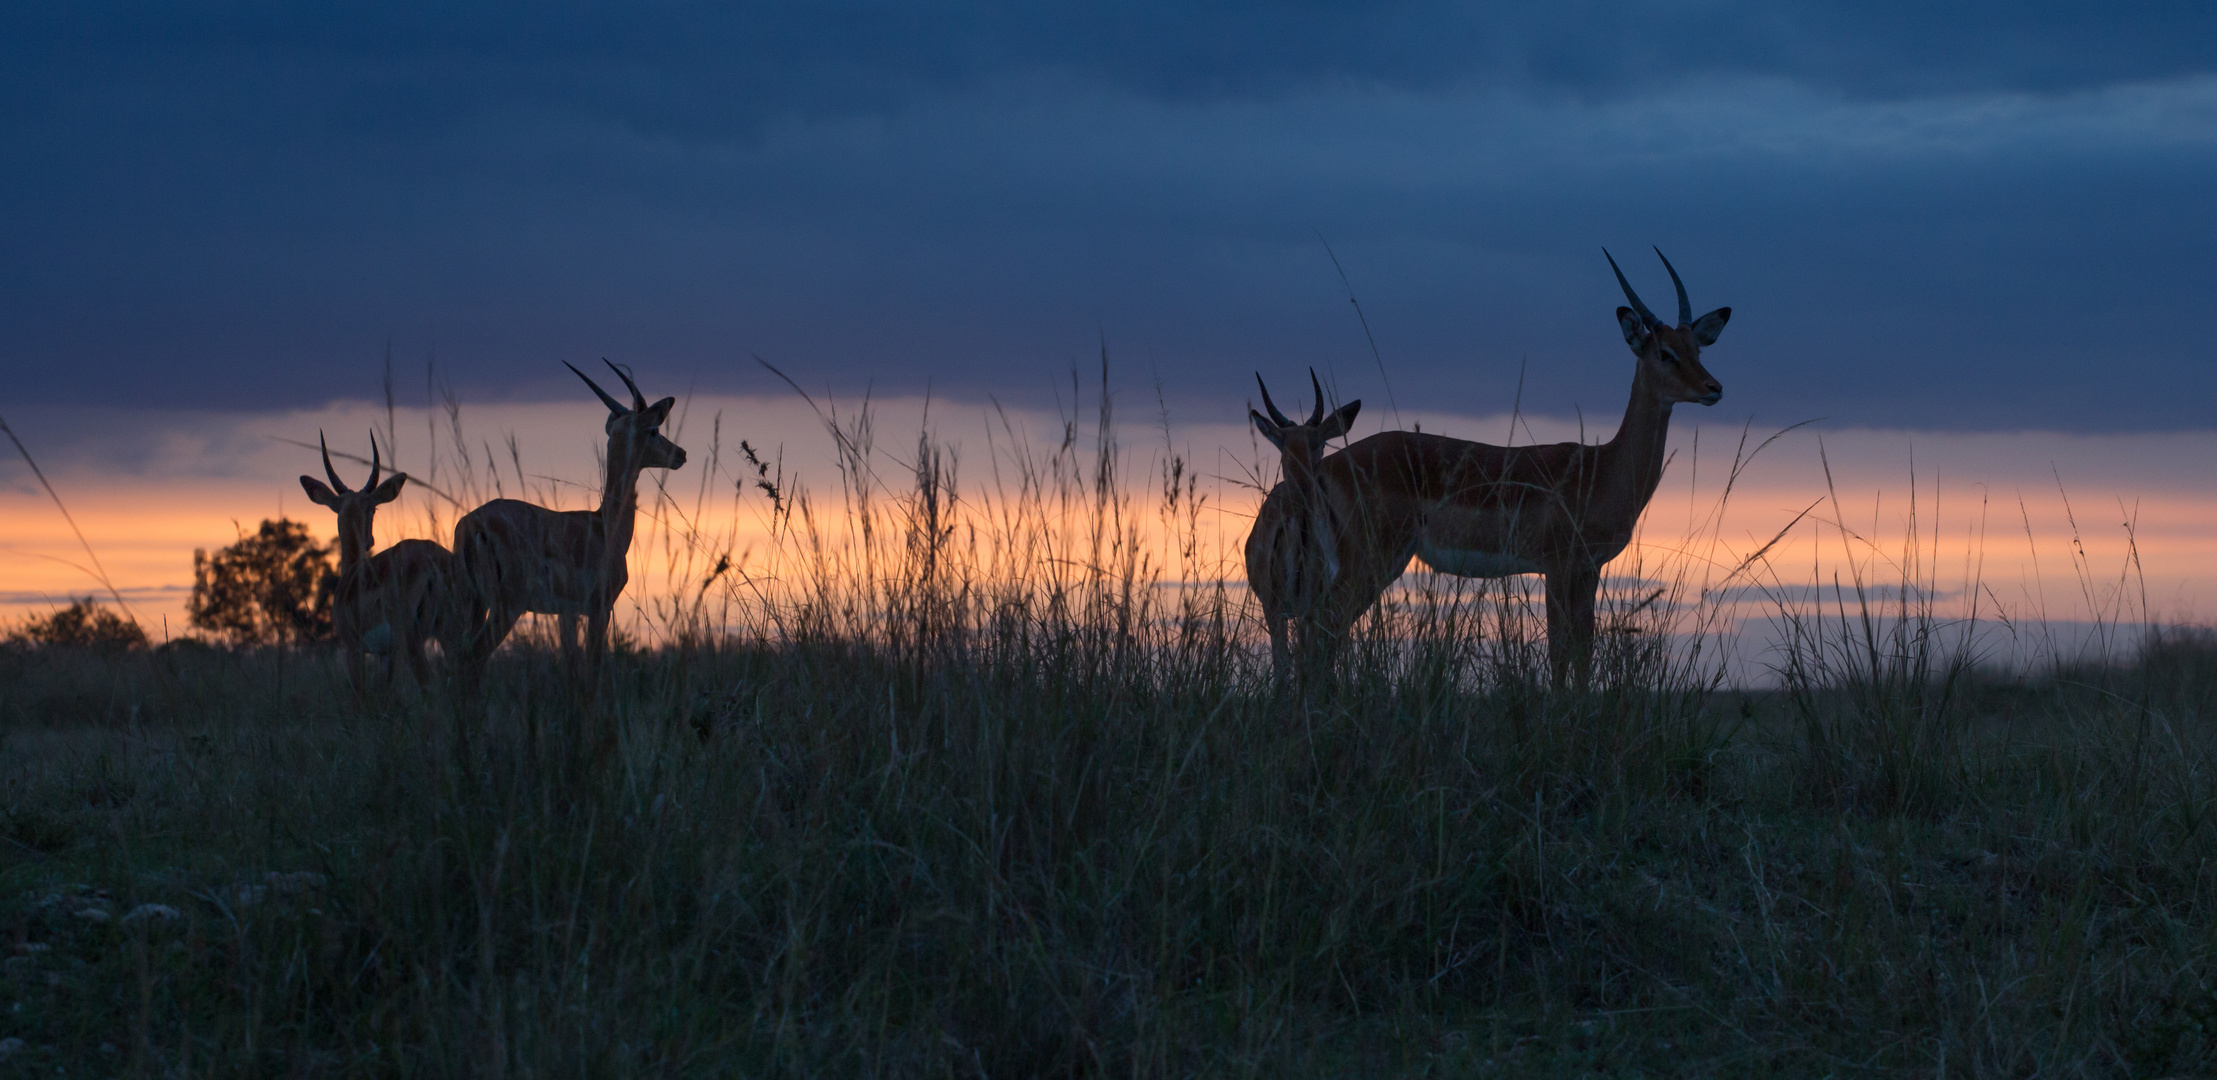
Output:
184,517,339,645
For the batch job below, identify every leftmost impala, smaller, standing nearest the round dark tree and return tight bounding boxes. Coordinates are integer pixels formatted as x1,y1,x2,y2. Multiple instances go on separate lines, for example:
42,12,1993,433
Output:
299,432,470,692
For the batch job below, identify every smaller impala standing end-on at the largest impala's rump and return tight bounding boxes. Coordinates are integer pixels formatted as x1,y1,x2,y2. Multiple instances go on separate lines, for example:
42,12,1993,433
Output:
1246,368,1363,683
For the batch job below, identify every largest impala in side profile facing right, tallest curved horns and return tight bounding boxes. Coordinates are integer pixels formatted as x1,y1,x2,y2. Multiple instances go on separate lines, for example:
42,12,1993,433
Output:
1276,248,1731,683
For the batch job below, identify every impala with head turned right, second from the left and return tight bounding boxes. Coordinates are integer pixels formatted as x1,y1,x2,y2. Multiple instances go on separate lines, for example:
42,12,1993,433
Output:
454,364,685,685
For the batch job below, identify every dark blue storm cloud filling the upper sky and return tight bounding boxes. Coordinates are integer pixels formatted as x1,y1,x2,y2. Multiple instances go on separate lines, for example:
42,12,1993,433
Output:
0,2,2217,428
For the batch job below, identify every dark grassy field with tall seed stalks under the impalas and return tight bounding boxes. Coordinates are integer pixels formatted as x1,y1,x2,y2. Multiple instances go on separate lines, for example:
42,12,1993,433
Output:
0,394,2217,1076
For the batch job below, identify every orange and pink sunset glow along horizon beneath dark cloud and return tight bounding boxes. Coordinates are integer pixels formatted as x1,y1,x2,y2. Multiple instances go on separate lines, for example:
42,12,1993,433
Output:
0,399,2217,639
